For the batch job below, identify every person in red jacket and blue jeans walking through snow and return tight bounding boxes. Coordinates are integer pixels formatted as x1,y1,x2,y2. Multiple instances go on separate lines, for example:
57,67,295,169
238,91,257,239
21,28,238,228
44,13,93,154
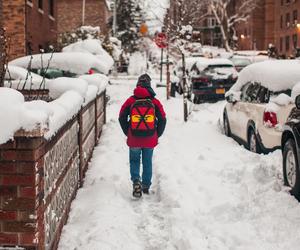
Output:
119,74,167,198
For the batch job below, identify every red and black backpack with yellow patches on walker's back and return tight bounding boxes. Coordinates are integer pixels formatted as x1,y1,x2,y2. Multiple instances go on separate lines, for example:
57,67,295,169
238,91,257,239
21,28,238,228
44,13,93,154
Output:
130,99,156,137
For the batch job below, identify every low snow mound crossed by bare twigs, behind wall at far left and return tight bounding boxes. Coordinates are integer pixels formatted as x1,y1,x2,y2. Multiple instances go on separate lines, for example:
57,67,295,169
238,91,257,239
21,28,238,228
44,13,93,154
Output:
4,65,50,89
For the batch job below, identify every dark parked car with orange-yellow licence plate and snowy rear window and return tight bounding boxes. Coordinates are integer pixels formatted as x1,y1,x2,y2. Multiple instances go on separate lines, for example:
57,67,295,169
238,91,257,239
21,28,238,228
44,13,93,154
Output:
190,58,238,103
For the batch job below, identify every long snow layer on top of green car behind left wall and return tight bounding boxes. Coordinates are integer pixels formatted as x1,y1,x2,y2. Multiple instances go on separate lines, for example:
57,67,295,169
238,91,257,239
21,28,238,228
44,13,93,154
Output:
9,52,109,75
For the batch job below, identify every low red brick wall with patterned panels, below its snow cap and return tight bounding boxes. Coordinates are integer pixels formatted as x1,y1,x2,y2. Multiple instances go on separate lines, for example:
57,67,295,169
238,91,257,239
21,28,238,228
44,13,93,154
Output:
0,92,106,250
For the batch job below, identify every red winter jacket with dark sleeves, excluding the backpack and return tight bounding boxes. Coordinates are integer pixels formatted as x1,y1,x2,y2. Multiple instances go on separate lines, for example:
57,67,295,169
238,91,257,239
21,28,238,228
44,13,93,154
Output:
119,86,167,148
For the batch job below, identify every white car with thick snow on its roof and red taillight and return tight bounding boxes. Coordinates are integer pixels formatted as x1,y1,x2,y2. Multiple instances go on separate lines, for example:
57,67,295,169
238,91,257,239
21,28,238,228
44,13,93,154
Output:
223,60,300,153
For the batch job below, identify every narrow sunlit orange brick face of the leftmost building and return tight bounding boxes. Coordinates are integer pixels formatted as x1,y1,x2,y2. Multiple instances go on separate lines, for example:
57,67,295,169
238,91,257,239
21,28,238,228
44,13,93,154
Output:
1,0,26,59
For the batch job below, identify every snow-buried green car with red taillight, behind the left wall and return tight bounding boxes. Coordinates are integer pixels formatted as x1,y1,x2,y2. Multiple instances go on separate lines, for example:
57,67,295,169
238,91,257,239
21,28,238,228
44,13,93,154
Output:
9,52,109,79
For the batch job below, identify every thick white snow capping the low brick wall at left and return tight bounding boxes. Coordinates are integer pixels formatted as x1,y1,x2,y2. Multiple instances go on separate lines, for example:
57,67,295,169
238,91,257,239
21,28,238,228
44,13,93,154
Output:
0,74,108,144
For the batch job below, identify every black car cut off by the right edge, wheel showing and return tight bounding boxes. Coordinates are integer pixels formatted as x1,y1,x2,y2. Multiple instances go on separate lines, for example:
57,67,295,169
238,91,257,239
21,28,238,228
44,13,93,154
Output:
281,95,300,200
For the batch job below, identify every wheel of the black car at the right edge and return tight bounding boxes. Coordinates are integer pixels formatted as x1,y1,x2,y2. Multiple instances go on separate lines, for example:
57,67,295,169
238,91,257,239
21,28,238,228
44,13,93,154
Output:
283,139,300,200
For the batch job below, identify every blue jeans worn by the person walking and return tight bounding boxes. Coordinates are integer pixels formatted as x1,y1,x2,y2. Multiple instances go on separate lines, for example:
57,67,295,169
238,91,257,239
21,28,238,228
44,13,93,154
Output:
129,148,153,188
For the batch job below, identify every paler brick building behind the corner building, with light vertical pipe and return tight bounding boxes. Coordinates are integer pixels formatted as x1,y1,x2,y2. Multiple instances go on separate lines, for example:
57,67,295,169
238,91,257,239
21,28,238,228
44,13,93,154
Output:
57,0,111,34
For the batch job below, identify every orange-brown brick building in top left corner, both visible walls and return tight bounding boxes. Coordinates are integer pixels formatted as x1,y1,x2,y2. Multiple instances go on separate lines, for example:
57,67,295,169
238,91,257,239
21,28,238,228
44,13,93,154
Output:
2,0,57,59
